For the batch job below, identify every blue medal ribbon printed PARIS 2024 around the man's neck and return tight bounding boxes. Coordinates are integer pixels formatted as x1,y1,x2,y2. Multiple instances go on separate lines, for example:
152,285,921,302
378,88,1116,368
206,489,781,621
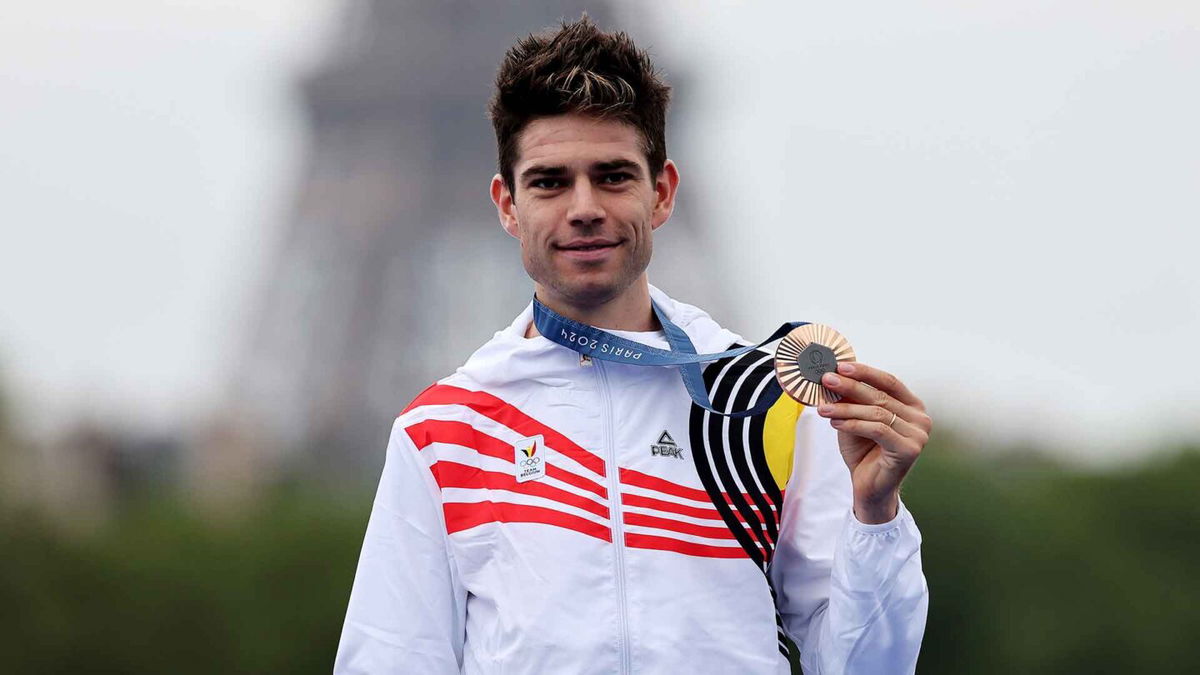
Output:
533,295,808,418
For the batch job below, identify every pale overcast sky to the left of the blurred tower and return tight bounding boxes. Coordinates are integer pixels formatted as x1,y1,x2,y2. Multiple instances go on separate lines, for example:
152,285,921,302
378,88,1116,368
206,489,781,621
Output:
0,0,331,437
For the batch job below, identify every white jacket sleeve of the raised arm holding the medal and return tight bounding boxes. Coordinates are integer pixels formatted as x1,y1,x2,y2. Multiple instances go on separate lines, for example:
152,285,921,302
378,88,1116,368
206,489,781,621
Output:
770,401,929,675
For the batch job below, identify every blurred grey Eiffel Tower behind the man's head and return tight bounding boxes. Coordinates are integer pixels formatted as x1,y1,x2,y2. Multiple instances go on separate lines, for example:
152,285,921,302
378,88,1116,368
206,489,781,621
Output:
197,0,720,478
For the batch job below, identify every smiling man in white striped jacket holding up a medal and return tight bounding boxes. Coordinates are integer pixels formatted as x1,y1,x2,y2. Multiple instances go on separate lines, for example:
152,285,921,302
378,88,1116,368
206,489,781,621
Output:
335,18,930,674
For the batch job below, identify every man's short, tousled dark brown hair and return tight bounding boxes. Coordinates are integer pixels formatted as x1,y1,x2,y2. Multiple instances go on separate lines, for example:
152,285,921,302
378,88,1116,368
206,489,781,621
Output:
488,14,671,190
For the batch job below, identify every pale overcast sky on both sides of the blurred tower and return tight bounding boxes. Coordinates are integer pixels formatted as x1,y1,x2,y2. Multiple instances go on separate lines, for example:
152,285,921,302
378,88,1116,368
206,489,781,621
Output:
0,0,1200,460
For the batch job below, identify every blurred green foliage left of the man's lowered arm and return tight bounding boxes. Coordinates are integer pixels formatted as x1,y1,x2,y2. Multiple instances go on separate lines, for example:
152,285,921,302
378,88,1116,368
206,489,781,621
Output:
0,480,370,674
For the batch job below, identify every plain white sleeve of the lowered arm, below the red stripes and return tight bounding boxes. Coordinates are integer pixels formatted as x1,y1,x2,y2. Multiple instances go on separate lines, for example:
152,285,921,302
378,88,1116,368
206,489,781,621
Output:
334,419,467,675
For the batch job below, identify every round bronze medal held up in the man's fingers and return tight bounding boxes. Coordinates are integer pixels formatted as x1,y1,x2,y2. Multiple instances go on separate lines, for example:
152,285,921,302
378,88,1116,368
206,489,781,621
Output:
775,323,854,406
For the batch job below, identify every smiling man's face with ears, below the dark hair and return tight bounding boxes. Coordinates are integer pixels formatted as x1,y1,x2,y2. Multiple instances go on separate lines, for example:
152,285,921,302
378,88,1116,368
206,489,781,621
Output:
492,114,679,306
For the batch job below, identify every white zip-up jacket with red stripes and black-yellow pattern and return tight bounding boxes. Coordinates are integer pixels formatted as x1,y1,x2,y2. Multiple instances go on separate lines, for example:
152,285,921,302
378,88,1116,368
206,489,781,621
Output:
334,287,928,675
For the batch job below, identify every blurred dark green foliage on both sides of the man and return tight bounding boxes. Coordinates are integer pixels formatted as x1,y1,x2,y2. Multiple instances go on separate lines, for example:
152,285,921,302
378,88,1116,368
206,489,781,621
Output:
0,396,1200,674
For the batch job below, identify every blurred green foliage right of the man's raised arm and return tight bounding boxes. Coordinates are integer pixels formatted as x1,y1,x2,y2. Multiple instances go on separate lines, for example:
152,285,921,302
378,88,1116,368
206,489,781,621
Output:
905,437,1200,674
